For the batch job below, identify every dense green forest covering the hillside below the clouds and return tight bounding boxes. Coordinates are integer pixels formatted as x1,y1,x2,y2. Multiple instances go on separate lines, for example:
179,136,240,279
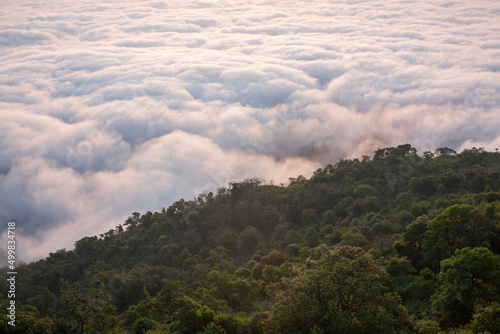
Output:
0,144,500,334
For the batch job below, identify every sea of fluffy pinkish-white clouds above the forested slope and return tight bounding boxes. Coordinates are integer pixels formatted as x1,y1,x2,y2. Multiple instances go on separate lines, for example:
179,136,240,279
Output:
0,0,500,261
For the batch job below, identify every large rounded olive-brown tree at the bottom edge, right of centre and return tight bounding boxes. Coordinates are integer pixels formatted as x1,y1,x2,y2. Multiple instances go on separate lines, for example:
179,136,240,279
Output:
264,246,406,333
